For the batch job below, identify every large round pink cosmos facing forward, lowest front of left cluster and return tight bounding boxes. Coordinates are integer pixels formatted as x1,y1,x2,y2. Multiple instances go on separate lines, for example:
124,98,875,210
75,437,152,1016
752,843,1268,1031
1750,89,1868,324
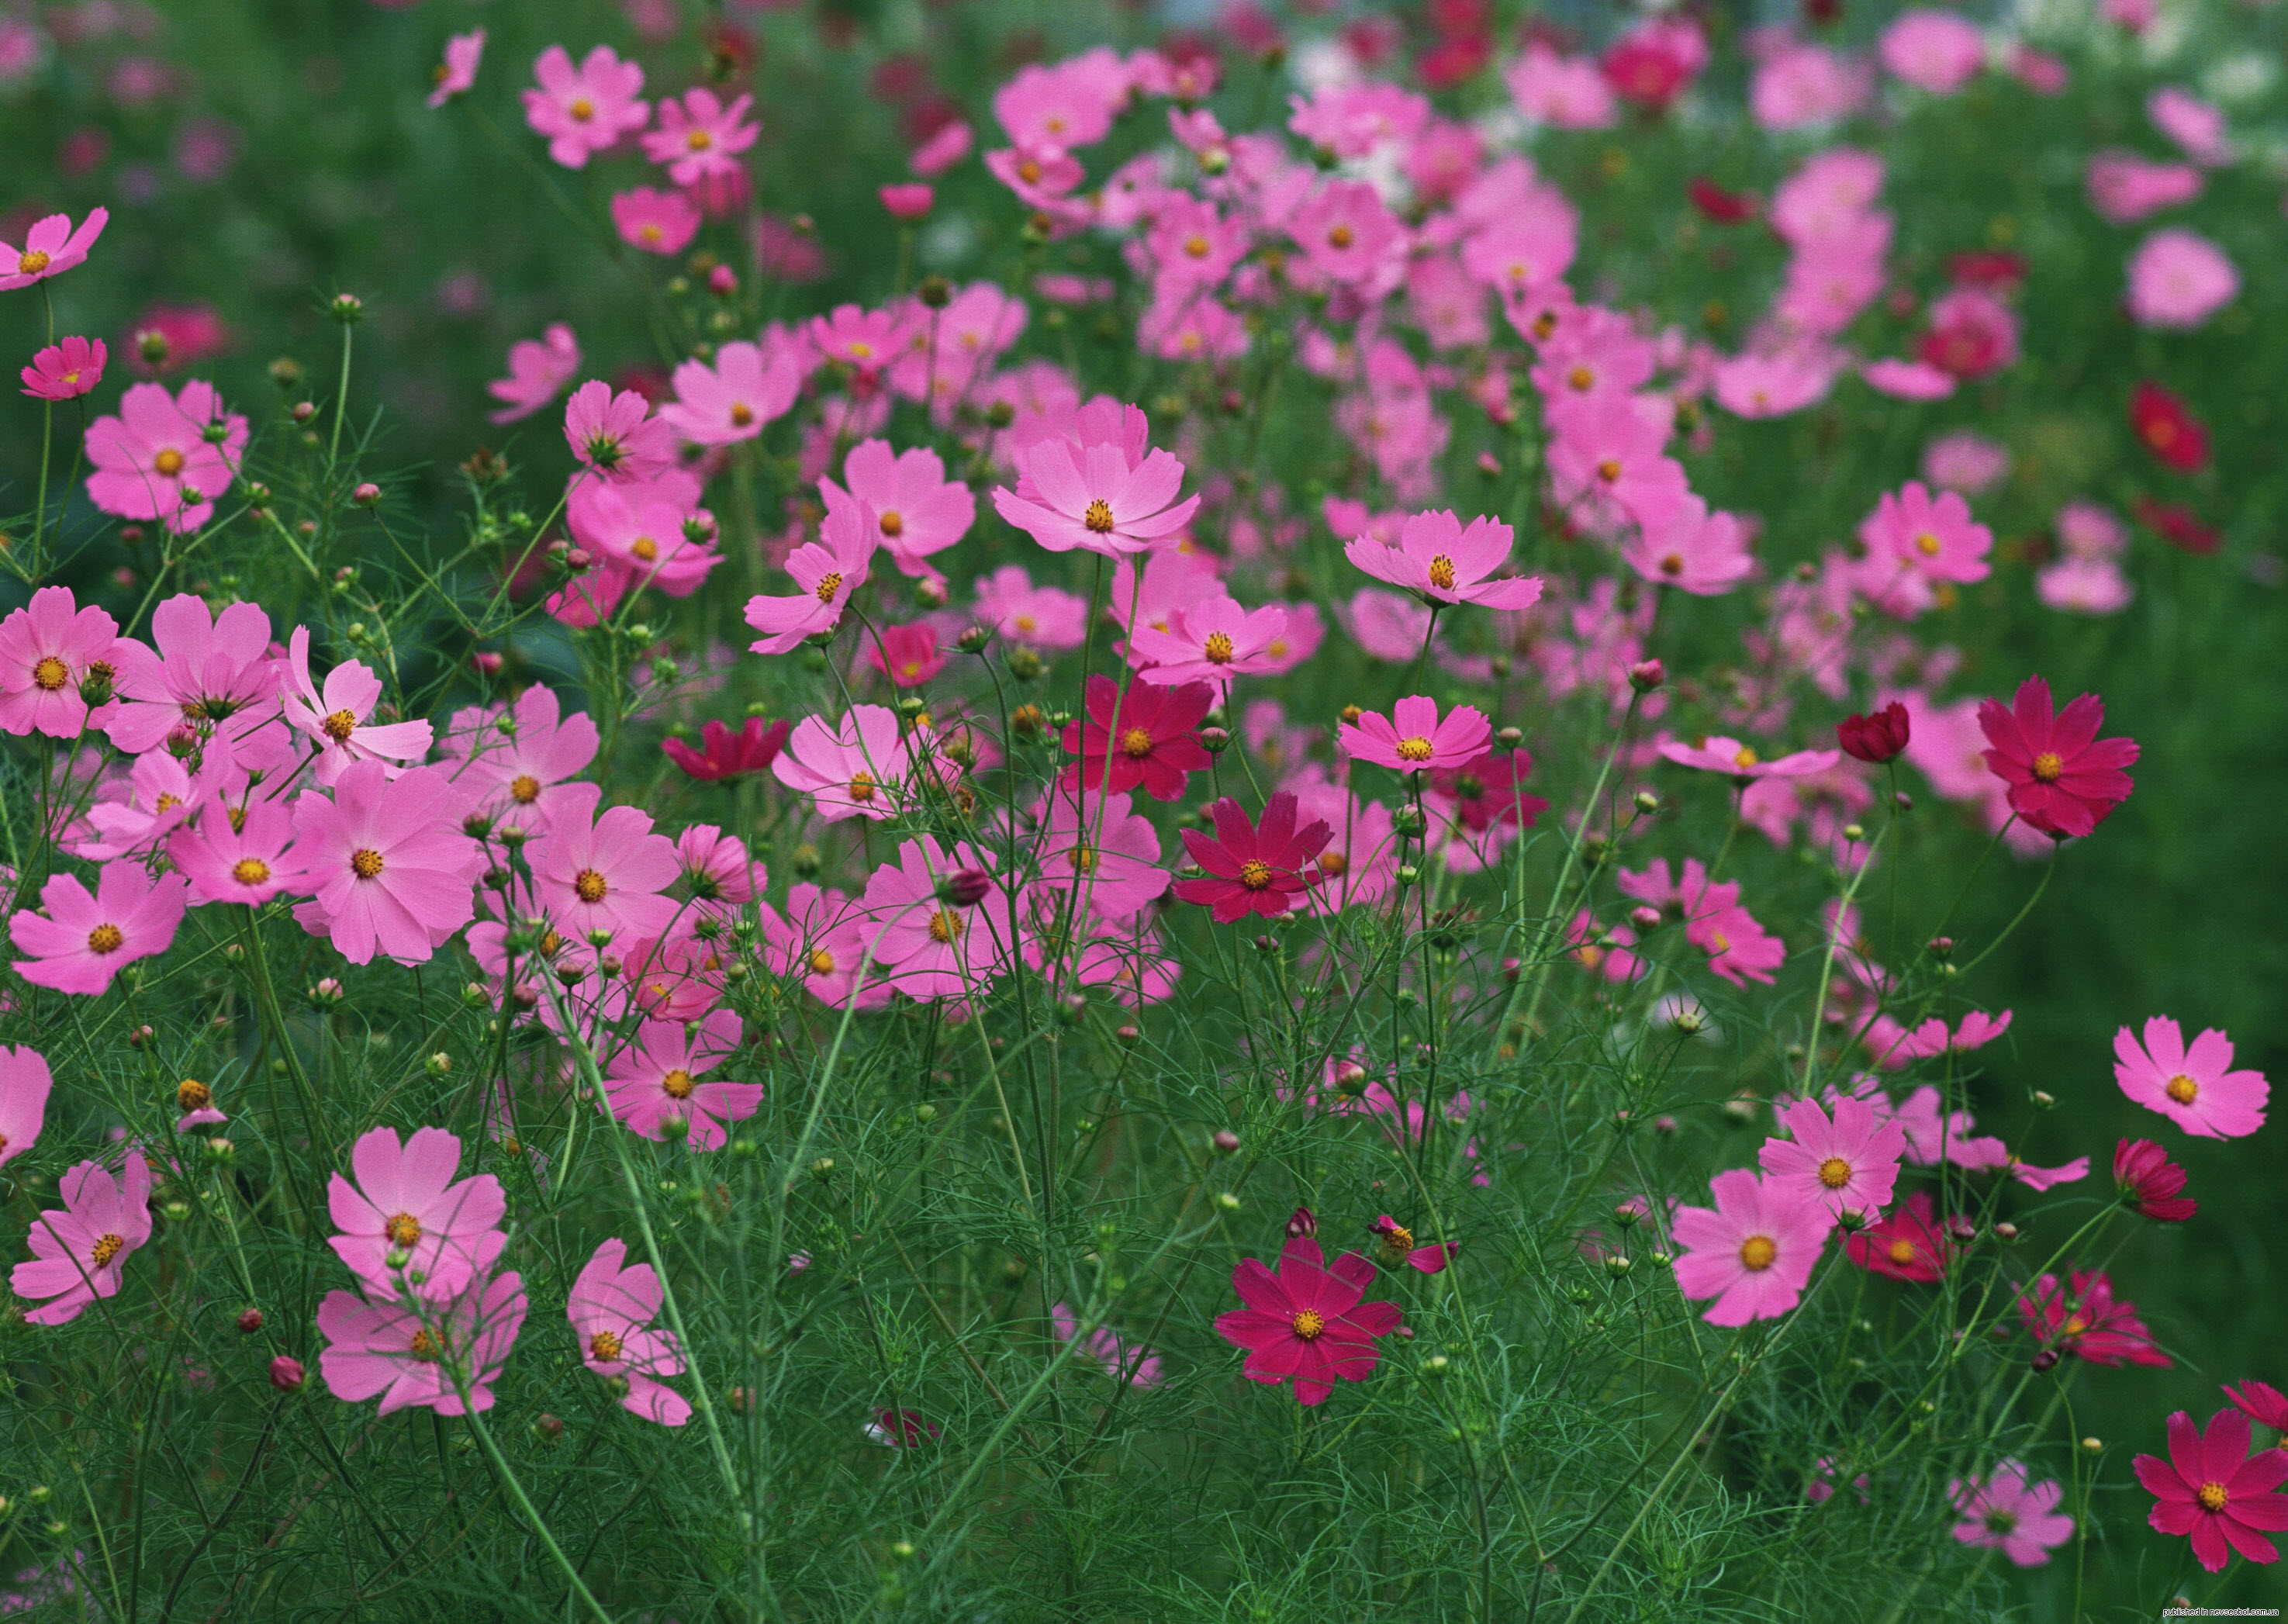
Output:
293,762,485,966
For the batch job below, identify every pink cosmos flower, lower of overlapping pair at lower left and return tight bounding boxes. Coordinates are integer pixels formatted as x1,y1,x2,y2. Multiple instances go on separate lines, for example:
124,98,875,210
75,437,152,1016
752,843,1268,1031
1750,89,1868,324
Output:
318,1280,528,1416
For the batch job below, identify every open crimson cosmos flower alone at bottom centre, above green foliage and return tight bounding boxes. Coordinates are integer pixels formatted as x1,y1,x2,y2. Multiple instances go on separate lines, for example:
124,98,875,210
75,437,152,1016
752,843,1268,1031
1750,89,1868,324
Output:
1215,1235,1398,1405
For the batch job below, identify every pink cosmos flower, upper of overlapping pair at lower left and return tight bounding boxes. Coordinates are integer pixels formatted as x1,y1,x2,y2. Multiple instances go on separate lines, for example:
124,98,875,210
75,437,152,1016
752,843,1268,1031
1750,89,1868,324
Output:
325,1128,508,1299
